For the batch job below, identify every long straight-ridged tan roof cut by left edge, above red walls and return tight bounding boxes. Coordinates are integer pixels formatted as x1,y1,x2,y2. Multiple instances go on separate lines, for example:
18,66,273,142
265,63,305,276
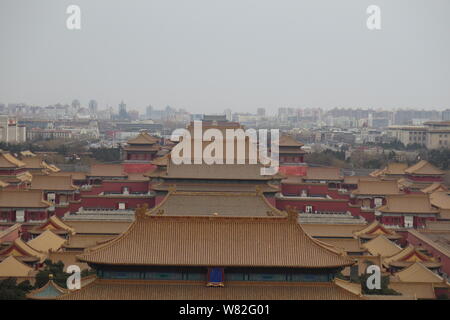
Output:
0,190,51,208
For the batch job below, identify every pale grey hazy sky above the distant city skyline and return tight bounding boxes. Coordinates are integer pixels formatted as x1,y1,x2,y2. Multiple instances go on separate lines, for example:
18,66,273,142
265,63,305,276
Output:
0,0,450,113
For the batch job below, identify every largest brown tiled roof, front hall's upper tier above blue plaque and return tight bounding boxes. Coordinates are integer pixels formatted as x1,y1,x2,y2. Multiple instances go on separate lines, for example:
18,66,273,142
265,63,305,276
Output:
78,208,354,268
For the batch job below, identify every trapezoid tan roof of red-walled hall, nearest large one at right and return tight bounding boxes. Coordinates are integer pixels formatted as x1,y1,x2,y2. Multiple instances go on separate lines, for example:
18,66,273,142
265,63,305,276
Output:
378,194,438,214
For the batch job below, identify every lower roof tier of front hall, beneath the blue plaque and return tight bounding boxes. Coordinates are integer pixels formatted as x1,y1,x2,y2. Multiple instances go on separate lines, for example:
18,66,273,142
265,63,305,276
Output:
57,279,362,300
